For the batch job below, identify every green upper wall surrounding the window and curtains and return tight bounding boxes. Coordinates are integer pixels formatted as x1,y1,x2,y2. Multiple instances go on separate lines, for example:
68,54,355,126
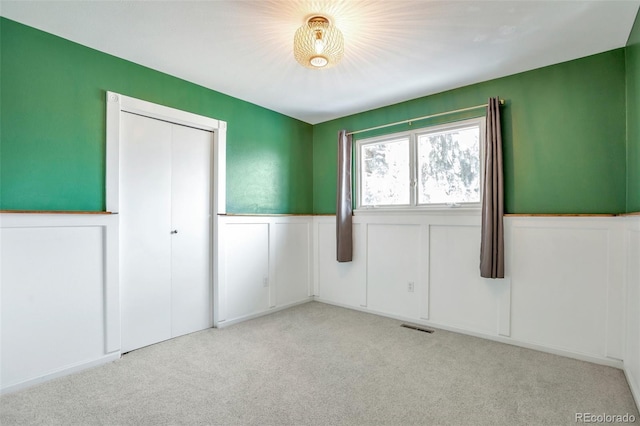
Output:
313,48,628,214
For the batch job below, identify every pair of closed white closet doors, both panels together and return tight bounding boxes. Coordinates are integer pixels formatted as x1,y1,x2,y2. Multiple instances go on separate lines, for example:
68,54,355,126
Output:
120,113,213,352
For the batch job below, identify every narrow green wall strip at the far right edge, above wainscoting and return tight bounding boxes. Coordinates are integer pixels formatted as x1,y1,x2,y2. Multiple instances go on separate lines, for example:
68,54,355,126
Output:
625,8,640,213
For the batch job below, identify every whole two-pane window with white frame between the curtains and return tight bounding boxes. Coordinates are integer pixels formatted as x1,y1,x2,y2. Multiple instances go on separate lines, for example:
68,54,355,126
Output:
356,117,485,208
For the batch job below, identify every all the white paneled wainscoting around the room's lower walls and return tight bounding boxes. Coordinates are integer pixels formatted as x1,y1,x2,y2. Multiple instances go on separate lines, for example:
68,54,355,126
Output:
0,211,640,401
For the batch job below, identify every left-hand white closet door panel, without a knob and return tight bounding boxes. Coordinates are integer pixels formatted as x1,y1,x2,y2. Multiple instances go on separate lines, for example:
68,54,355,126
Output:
119,114,172,352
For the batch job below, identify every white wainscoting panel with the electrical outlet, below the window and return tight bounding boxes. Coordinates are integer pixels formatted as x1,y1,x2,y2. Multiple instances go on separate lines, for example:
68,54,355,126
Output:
366,224,427,318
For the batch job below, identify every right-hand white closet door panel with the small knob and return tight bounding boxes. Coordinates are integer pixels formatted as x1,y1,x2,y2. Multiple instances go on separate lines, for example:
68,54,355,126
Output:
171,125,213,337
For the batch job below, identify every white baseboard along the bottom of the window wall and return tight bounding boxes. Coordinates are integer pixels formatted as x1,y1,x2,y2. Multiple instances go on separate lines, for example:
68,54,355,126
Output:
315,296,623,369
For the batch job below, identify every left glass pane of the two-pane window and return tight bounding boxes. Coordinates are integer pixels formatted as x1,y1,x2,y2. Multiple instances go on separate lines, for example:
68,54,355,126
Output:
360,139,411,206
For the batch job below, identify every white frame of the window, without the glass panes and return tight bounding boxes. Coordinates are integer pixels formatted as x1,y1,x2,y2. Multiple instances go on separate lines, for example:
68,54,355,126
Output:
355,117,486,213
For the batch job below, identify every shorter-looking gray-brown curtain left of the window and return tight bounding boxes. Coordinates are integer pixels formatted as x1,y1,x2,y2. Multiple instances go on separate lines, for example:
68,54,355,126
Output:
336,130,353,262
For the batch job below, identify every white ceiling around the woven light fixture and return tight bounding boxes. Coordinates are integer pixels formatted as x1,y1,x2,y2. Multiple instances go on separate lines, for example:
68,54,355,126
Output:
0,0,640,124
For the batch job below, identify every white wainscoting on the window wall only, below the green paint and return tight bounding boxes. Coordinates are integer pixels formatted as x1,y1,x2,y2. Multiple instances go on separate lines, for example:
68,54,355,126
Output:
314,212,626,367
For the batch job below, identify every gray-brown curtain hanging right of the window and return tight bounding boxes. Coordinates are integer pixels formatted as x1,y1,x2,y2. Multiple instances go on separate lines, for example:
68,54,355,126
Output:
480,98,504,278
